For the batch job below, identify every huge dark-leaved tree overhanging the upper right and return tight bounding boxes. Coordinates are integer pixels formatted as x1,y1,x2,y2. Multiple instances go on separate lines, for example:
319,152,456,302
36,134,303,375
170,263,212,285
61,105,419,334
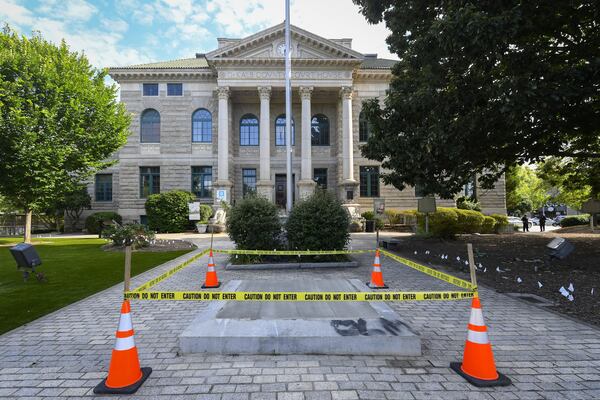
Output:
353,0,600,198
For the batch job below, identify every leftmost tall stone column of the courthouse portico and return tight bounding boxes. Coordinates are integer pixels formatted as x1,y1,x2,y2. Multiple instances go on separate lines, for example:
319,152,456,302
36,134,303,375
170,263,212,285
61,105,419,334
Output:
214,86,233,204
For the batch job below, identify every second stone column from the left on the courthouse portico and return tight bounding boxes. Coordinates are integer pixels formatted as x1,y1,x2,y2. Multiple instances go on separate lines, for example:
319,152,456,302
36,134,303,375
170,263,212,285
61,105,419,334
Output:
256,86,273,201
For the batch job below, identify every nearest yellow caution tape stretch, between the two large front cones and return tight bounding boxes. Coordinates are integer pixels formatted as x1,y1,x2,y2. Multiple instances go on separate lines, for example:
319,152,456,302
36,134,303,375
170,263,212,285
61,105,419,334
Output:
125,291,477,302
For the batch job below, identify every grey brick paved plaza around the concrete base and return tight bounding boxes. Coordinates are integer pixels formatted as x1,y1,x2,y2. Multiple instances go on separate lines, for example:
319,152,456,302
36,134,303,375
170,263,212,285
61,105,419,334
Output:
0,235,600,400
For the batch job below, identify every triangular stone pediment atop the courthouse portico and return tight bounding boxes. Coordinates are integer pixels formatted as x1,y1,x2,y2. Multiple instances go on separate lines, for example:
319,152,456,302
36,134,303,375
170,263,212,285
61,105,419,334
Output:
206,23,364,61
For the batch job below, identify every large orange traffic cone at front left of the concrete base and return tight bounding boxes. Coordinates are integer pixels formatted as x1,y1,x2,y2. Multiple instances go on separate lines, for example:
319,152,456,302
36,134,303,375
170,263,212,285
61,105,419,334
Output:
94,300,152,394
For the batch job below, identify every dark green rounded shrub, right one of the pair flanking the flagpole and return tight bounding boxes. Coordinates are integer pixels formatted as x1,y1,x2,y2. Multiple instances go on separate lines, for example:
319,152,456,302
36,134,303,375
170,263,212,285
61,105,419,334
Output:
286,190,352,250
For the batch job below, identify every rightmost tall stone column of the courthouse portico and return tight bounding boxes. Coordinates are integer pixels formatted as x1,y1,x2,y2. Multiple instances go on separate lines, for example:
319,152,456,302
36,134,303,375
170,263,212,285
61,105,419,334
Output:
340,86,357,202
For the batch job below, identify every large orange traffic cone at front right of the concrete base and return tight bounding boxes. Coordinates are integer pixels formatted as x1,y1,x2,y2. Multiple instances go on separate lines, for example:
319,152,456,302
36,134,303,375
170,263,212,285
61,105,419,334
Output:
450,296,511,387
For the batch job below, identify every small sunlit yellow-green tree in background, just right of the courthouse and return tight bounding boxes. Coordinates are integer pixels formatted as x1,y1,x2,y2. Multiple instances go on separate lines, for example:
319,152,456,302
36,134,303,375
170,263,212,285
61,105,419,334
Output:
506,165,550,215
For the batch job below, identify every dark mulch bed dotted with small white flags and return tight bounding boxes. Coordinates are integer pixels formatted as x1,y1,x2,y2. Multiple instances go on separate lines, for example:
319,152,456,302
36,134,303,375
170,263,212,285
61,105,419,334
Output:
396,231,600,325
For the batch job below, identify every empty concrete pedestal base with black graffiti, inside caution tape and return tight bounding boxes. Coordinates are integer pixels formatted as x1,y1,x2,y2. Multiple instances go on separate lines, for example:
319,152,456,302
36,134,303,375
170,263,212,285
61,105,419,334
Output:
179,279,421,356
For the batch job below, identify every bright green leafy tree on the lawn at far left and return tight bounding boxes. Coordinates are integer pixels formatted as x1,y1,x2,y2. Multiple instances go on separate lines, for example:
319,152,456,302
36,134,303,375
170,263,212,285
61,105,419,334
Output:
0,27,130,242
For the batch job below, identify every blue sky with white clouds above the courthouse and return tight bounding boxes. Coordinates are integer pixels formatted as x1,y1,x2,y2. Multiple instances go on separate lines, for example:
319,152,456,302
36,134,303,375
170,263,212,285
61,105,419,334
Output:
0,0,397,68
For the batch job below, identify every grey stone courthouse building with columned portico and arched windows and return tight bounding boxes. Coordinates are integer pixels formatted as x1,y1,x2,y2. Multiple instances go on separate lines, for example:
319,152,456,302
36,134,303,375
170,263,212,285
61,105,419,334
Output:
90,24,506,222
